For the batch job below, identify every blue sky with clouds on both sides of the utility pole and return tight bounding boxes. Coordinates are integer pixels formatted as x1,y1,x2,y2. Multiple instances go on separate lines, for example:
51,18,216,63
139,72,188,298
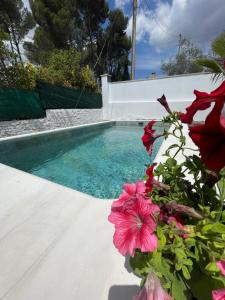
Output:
24,0,225,79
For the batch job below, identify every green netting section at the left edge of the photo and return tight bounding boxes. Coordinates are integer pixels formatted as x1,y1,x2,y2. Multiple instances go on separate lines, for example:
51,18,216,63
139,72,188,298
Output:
0,88,46,121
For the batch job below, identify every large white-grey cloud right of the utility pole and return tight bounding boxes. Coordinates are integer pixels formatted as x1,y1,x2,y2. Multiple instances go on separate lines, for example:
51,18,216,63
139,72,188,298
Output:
126,0,225,49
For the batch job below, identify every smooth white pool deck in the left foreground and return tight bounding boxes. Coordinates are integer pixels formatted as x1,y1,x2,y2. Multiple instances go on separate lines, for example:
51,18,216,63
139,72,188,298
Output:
0,122,197,300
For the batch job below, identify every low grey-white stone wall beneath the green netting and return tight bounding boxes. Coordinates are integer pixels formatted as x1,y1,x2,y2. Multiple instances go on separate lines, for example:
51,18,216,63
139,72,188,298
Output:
0,109,102,137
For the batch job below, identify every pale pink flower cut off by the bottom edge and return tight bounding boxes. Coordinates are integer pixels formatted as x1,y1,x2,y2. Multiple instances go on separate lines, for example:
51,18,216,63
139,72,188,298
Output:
133,273,172,300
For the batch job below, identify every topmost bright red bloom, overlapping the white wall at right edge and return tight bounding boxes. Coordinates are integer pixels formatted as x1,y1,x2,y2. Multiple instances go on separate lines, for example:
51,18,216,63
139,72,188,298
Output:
180,81,225,124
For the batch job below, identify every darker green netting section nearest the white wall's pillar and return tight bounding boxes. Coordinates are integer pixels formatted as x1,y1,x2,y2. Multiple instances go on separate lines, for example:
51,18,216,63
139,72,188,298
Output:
37,82,102,109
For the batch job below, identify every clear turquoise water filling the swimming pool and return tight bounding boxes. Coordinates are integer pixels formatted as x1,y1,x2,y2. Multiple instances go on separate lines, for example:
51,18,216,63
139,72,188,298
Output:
0,126,163,199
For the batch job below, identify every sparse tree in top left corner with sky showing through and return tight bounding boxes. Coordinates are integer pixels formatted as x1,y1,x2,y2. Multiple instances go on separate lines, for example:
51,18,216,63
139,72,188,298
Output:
0,0,35,63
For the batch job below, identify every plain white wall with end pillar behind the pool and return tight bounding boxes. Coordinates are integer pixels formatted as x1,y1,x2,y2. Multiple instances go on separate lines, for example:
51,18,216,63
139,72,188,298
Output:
102,74,219,120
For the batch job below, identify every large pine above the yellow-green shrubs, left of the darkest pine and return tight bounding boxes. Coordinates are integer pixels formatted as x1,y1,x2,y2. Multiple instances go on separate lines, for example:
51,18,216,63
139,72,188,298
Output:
24,0,108,67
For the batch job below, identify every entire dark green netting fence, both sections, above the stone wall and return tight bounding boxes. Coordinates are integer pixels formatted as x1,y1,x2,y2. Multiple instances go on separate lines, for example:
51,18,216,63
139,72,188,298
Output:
0,82,102,121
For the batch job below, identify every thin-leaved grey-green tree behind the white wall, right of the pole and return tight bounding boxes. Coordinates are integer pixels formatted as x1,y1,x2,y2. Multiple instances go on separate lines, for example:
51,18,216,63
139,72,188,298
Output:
161,38,203,75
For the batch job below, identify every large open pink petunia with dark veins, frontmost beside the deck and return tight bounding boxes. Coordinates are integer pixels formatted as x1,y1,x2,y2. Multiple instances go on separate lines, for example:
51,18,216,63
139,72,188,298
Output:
108,195,159,256
